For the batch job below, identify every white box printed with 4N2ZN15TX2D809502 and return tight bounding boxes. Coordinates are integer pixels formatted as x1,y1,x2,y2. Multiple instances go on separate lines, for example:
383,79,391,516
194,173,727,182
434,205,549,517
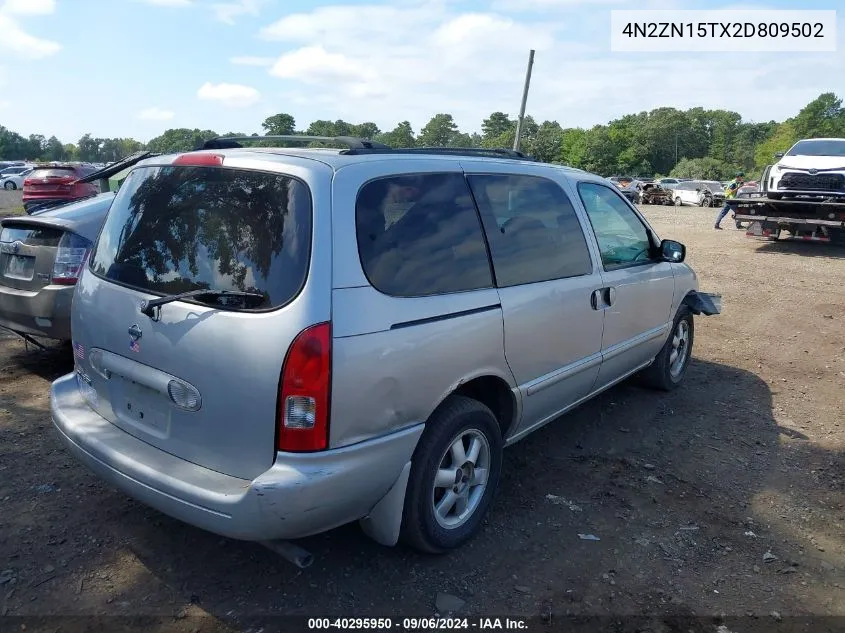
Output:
610,10,836,52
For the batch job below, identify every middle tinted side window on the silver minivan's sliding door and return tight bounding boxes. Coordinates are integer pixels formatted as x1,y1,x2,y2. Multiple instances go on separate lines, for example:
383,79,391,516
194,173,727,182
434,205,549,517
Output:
469,174,593,287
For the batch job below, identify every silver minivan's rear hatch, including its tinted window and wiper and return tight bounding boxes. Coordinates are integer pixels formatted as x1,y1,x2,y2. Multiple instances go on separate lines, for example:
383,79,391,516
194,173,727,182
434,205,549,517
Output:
72,155,312,479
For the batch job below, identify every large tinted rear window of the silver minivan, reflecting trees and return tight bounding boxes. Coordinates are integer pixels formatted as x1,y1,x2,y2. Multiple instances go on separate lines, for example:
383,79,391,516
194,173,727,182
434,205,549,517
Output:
91,167,312,310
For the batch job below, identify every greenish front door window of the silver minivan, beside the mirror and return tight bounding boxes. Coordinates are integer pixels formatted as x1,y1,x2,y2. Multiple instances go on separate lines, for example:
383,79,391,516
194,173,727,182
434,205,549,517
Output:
578,182,652,270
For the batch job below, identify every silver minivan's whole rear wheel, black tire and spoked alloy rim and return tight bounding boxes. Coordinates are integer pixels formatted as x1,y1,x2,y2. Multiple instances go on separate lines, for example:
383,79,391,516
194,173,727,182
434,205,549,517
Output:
402,396,503,554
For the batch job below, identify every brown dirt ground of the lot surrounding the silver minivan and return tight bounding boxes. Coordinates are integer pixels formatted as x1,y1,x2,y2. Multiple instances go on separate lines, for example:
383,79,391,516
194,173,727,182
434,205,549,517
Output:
0,207,845,631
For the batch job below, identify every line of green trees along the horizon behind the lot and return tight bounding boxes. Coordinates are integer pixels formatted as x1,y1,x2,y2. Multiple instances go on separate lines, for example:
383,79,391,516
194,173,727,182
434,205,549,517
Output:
0,92,845,179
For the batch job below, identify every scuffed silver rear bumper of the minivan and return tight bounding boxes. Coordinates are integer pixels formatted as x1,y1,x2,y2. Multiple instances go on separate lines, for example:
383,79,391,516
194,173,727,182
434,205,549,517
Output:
50,374,422,541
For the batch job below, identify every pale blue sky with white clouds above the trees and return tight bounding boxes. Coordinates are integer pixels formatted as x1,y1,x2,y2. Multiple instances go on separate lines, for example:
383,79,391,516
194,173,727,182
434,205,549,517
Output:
0,0,845,142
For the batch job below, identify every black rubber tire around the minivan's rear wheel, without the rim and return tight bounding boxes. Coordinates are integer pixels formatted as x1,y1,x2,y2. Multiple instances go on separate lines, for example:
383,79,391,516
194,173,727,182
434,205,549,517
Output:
401,396,503,554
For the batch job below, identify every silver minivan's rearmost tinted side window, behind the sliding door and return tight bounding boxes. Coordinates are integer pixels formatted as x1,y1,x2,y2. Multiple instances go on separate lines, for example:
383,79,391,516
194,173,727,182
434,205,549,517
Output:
355,173,493,297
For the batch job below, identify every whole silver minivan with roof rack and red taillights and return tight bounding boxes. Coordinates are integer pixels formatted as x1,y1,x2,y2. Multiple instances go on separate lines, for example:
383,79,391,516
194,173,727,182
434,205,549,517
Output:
51,137,720,552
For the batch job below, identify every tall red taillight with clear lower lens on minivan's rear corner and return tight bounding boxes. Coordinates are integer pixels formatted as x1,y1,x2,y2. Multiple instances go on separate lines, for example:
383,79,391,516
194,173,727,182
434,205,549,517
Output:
276,323,332,452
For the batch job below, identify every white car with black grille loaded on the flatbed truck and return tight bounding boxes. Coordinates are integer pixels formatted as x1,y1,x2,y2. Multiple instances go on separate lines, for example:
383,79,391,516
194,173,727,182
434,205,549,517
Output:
763,138,845,199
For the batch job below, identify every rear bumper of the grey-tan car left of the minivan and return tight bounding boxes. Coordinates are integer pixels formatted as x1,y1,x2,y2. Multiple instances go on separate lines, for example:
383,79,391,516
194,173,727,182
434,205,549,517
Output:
0,285,74,341
